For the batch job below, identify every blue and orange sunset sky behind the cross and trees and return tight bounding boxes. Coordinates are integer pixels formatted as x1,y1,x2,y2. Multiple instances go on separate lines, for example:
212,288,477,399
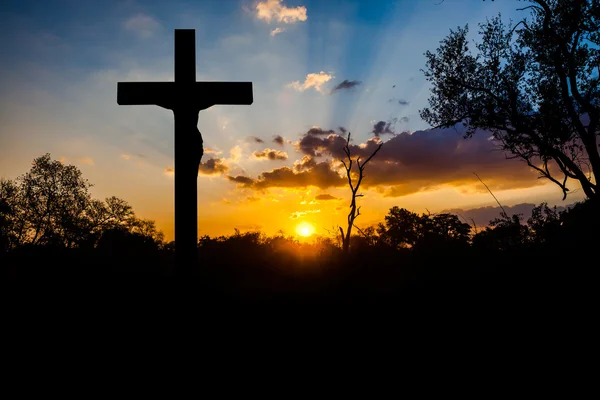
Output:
0,0,581,239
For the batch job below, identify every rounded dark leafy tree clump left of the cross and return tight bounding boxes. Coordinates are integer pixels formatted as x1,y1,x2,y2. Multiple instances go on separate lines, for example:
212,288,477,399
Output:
0,154,164,249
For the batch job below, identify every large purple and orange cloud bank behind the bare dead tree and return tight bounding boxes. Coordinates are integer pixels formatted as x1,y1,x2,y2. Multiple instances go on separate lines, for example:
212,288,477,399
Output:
253,122,546,197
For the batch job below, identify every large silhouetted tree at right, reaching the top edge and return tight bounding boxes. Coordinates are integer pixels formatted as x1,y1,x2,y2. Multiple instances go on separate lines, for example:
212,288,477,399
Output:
420,0,600,202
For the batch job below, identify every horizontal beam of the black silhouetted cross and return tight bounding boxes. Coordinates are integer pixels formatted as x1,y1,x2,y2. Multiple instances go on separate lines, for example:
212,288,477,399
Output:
117,82,253,109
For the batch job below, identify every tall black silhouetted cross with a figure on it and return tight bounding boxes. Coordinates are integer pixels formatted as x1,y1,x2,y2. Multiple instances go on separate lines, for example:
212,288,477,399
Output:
117,29,253,274
